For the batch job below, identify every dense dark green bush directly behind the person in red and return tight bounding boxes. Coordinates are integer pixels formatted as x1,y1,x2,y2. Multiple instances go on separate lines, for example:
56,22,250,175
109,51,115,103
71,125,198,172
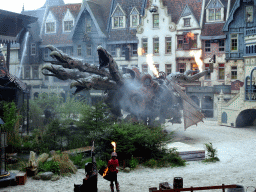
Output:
91,123,171,160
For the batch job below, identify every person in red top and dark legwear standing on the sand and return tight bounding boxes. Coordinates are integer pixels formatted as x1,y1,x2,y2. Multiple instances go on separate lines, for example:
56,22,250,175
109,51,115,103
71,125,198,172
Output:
108,152,120,192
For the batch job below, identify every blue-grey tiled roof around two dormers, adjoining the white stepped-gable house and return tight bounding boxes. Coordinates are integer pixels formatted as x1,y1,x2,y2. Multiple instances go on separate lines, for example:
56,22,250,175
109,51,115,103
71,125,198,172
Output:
108,0,144,41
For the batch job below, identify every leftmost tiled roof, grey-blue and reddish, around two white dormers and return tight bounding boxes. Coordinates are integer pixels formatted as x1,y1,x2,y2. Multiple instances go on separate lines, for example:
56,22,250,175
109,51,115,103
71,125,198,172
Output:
41,3,81,45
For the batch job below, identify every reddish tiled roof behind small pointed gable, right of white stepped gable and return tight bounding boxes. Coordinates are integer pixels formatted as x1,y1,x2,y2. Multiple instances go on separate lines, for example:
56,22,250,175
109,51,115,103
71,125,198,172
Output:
163,0,202,24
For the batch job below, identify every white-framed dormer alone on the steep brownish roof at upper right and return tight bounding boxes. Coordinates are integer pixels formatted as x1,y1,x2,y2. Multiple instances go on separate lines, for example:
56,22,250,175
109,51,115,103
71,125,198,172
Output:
206,0,224,22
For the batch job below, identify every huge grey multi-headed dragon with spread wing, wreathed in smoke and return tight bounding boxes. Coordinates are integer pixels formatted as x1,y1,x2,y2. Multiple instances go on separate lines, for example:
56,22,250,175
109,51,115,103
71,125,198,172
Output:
42,45,212,129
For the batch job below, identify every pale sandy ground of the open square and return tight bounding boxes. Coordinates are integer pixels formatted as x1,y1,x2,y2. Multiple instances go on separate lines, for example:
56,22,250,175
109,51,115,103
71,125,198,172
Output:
0,120,256,192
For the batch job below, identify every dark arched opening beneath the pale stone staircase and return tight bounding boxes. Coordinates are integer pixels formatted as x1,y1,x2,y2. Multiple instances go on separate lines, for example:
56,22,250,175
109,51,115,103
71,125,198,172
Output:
236,109,256,127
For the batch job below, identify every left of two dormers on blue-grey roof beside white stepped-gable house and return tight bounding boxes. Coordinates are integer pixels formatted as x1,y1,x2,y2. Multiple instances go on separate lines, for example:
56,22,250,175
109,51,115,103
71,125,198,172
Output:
112,4,126,29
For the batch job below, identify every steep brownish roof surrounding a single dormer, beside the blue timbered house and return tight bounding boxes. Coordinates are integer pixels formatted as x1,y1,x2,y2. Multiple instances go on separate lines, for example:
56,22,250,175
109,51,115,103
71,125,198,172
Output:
201,0,228,39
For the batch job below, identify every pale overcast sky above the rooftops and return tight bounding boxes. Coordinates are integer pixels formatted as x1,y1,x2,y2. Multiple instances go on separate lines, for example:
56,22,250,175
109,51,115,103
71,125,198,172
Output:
0,0,82,13
